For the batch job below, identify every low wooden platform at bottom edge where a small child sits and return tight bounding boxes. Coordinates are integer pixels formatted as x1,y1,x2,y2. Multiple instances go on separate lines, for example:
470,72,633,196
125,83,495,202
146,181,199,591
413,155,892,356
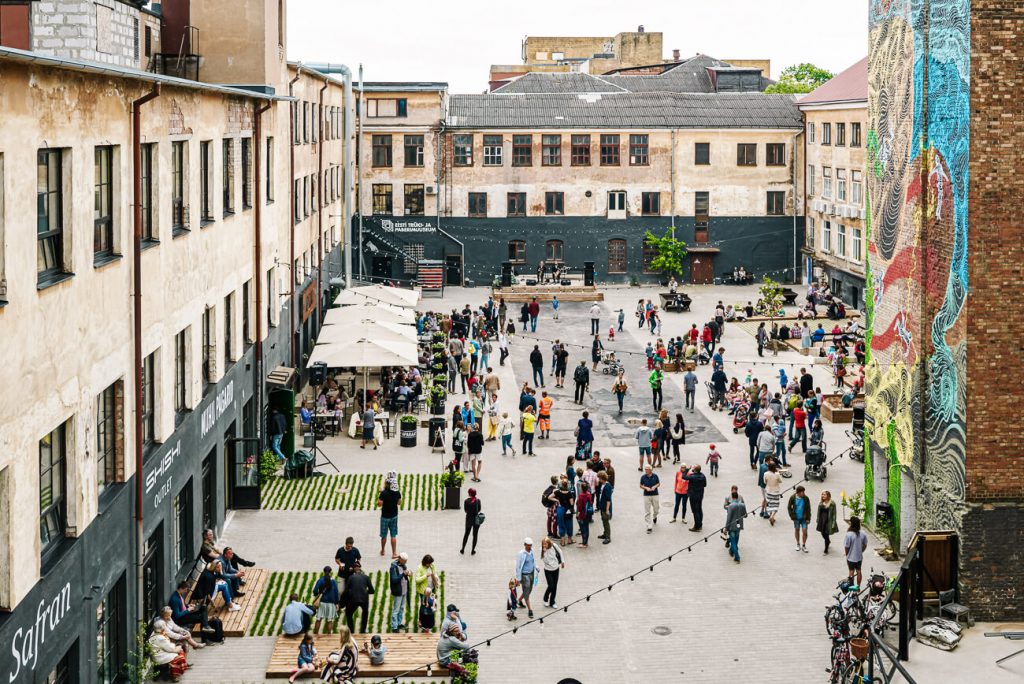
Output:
266,633,449,679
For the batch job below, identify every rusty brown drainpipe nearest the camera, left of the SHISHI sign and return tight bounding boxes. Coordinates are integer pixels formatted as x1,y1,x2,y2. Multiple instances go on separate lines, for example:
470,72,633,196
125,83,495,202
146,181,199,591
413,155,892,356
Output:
131,83,160,634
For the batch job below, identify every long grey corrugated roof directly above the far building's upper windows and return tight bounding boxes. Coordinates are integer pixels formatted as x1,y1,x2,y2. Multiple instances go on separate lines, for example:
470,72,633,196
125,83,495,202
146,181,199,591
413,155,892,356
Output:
445,92,803,129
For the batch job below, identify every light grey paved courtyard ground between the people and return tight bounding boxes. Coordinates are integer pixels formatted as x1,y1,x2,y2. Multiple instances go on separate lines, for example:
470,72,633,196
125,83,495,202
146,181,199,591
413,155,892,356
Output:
183,287,1015,684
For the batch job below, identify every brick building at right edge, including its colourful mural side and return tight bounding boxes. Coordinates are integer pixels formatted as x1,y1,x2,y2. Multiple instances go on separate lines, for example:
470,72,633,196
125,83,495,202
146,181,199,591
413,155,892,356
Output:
865,0,1024,619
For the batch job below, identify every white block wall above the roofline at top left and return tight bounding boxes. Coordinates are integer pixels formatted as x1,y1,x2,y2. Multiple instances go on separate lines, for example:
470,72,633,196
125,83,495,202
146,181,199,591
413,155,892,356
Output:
32,0,141,69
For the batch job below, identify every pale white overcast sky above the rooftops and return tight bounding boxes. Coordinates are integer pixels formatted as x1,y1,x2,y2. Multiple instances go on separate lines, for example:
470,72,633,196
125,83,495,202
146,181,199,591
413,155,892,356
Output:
288,0,867,92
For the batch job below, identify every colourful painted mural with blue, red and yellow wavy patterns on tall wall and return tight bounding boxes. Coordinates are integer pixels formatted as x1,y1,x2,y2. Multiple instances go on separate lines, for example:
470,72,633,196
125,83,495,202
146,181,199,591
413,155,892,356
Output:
865,0,971,545
